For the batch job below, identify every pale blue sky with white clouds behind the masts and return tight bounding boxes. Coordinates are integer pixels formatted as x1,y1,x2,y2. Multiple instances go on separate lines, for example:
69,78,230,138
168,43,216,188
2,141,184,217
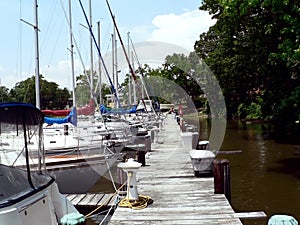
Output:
0,0,215,89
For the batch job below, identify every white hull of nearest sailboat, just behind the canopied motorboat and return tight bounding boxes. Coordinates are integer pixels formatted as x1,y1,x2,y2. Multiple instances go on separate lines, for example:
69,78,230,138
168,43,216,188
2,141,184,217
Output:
0,146,118,193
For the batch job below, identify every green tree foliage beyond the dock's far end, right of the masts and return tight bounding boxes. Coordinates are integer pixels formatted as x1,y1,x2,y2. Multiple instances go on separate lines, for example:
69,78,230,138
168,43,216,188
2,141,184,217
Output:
122,57,203,108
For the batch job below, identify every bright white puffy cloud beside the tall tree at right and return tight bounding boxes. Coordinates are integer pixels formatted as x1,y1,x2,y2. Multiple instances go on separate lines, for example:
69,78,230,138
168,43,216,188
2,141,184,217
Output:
149,10,216,51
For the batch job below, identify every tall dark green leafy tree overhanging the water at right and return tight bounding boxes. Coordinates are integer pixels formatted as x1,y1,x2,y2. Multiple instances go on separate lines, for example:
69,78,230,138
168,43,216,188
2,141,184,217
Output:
195,0,300,117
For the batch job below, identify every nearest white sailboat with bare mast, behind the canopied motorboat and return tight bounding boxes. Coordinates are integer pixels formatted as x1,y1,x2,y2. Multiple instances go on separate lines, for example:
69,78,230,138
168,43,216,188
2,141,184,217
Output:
25,0,117,193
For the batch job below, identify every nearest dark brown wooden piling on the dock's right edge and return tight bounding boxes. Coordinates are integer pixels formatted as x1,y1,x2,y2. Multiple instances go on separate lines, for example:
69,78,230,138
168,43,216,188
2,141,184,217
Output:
213,159,231,202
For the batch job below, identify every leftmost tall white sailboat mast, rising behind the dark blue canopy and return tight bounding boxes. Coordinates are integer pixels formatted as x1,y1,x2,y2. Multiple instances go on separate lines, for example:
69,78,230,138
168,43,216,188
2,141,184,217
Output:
34,0,41,109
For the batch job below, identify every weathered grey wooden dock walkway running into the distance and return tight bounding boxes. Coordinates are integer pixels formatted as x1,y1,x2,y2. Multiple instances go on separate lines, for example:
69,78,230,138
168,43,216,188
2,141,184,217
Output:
109,115,247,225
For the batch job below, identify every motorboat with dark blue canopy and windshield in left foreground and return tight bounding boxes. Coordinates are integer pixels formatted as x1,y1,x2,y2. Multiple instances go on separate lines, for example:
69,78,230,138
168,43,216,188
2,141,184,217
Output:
0,103,83,225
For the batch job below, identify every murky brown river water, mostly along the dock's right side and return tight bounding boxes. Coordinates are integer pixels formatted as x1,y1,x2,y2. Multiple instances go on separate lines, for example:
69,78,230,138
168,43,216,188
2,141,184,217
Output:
87,119,300,225
